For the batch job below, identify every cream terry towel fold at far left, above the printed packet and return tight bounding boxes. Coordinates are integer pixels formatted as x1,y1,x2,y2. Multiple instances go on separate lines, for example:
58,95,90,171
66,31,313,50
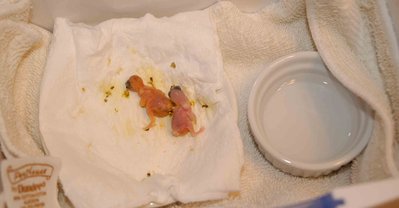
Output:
0,0,50,157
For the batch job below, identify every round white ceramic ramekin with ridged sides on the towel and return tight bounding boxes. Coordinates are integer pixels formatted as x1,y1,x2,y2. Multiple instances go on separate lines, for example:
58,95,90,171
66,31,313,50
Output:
248,52,373,177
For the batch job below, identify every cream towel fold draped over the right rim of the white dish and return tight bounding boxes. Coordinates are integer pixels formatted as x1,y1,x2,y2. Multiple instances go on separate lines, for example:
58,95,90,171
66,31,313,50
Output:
307,0,399,182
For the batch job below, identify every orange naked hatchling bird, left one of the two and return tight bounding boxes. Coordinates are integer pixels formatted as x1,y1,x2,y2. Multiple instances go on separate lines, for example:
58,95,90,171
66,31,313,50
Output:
126,75,173,130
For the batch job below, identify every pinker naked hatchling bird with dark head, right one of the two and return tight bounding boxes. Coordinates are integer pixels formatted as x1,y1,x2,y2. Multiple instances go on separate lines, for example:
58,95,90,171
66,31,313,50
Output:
169,86,204,137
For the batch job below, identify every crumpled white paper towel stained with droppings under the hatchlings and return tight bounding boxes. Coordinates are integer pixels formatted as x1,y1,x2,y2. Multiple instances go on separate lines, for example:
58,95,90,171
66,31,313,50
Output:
40,10,243,208
